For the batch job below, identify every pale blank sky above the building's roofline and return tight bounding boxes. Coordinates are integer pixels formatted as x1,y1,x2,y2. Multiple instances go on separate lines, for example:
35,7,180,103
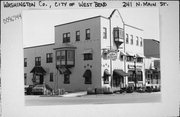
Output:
23,8,159,47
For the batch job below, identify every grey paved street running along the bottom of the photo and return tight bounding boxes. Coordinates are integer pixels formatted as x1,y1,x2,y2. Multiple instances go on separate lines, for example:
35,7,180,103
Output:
25,92,161,106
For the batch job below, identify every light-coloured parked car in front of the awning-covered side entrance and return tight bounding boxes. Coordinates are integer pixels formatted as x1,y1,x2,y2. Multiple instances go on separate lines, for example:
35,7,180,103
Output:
32,84,52,95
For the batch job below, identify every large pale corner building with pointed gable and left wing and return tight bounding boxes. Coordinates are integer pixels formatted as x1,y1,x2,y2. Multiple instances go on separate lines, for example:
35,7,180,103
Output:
24,10,145,91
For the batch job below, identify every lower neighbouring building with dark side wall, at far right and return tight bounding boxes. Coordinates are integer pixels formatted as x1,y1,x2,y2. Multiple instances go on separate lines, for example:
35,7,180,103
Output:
144,39,161,87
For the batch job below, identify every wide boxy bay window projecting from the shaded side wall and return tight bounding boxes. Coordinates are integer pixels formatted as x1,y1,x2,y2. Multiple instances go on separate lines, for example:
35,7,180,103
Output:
56,50,75,66
